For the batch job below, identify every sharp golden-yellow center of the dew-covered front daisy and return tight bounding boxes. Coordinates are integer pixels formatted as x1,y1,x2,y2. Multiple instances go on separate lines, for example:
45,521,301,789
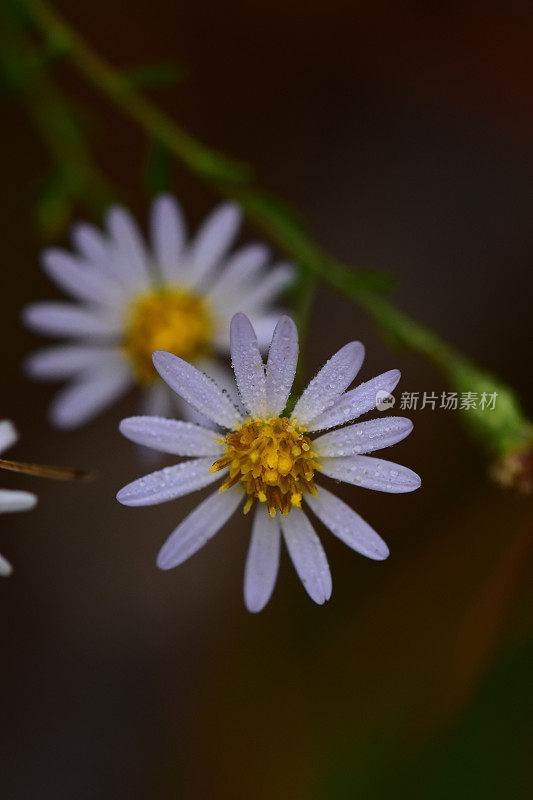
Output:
211,417,320,517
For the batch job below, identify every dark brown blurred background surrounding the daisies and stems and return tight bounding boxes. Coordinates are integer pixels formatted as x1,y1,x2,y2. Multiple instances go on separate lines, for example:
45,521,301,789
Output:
0,0,533,800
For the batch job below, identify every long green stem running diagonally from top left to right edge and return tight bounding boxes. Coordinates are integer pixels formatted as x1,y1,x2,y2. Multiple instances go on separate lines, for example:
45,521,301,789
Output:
18,0,533,476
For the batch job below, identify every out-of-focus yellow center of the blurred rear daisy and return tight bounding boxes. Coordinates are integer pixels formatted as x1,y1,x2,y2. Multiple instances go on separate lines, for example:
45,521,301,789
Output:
123,288,212,383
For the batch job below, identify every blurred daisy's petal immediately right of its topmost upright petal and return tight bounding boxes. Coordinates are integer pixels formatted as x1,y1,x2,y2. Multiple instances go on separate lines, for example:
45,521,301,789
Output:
189,203,242,286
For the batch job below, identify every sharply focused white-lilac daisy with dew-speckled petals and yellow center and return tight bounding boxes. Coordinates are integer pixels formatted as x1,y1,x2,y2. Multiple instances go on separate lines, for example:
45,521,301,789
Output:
117,313,420,611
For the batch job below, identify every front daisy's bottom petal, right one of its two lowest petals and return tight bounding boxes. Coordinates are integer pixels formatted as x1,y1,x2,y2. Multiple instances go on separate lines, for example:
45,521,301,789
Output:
281,508,332,605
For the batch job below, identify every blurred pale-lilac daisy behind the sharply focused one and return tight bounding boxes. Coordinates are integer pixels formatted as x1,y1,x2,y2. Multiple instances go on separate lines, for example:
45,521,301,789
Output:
23,195,293,428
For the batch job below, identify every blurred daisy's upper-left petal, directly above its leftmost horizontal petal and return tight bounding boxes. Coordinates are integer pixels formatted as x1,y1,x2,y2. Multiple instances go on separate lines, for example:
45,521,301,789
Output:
41,247,121,305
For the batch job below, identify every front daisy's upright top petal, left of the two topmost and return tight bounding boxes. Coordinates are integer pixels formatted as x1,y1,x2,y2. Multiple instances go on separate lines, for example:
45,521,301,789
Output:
230,313,266,417
